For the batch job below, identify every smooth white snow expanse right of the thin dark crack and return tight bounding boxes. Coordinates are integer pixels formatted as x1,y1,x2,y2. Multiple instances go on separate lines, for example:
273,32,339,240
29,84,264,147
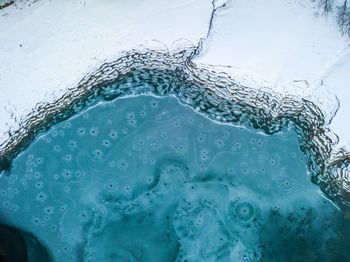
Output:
195,0,350,145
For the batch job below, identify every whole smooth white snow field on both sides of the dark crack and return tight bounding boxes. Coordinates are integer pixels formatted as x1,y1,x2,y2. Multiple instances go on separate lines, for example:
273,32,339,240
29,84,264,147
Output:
0,0,350,146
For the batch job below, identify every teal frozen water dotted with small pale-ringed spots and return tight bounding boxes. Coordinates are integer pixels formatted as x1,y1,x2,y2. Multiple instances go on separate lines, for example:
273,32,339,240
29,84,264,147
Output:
0,96,350,262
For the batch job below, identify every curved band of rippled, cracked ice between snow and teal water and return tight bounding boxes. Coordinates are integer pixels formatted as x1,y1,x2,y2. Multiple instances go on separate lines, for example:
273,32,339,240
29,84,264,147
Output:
0,47,350,208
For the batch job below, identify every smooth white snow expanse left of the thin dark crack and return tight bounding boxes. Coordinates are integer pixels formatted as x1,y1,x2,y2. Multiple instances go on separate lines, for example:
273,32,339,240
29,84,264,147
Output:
0,0,212,143
